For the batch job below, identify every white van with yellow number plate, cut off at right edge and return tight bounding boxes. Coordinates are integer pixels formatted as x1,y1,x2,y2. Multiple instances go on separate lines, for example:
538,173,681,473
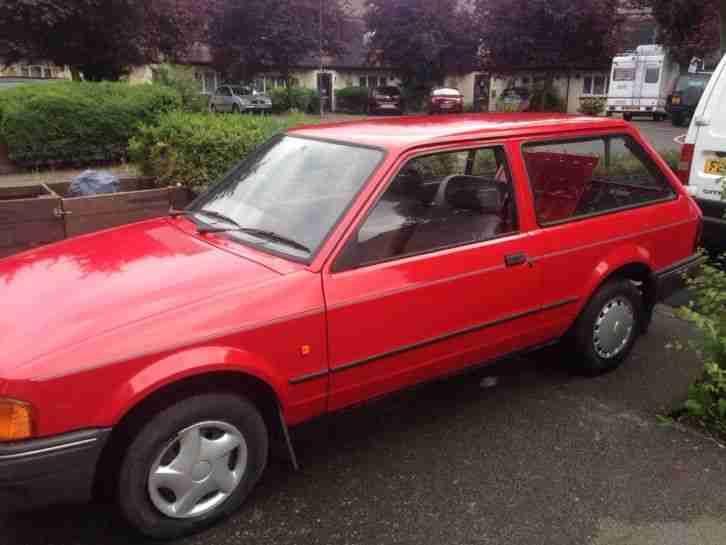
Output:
678,52,726,251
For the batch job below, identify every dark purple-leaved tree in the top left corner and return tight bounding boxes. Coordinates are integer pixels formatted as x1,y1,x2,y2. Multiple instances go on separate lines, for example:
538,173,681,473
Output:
0,0,211,80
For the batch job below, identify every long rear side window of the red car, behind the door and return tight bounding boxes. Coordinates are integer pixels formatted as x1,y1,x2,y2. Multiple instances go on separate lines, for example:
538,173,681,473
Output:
523,135,675,225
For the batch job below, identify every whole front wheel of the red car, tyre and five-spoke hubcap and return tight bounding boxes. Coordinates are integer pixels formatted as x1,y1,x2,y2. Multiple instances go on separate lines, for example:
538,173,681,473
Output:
118,394,268,539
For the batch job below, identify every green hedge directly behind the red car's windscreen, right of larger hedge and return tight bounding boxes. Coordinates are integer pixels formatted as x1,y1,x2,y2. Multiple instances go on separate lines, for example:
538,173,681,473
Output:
129,112,318,191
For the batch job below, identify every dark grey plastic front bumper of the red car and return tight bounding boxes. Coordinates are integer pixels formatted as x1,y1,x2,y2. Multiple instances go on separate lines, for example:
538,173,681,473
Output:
0,429,111,511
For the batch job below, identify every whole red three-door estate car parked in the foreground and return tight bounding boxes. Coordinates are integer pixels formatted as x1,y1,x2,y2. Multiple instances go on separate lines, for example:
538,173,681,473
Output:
0,114,701,538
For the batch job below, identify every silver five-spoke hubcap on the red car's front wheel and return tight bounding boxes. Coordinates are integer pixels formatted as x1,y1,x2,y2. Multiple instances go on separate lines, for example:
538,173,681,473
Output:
148,421,247,518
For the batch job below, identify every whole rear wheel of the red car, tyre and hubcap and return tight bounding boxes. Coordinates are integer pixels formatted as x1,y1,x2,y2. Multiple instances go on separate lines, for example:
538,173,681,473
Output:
574,279,644,374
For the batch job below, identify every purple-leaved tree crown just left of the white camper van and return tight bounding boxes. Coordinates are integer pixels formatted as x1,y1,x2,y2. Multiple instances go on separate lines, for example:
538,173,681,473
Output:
476,0,622,68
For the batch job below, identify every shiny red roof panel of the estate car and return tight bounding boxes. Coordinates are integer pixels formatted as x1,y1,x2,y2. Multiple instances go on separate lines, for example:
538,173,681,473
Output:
288,113,627,149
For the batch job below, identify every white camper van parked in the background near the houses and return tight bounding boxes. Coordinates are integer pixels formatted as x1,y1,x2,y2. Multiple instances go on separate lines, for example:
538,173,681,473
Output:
607,45,680,121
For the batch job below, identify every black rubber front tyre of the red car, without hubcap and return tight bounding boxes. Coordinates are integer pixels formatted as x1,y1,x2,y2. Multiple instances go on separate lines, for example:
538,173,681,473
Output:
118,394,269,539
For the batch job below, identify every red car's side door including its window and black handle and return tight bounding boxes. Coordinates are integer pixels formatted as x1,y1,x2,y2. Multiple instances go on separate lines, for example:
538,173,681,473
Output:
323,145,540,410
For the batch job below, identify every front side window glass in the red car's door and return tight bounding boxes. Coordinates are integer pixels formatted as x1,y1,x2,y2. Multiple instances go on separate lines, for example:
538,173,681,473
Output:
336,146,517,270
